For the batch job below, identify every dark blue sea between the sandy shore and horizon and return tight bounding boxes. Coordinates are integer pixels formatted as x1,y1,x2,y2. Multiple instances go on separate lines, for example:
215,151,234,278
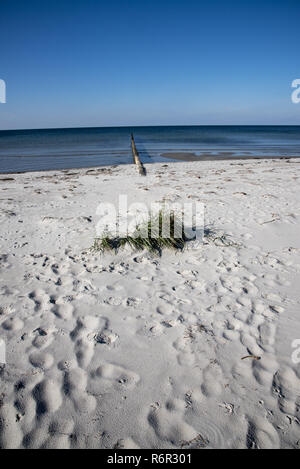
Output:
0,126,300,173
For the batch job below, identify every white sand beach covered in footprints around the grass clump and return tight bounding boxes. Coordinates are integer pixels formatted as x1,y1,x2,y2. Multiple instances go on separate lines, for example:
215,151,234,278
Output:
0,159,300,449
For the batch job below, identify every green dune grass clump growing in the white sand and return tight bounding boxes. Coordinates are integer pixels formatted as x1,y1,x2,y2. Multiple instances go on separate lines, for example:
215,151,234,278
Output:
93,210,188,255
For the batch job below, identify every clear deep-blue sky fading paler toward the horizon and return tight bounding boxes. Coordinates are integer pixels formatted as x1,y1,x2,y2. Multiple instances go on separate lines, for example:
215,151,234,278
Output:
0,0,300,129
